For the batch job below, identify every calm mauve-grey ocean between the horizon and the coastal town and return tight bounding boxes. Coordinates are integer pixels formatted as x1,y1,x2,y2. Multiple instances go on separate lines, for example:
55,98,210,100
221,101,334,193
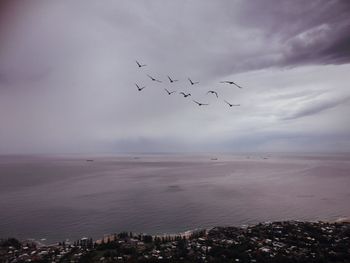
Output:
0,154,350,242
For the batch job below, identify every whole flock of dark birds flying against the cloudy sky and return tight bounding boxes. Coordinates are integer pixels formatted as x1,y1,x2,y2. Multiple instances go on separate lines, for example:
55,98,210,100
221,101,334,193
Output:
135,60,242,107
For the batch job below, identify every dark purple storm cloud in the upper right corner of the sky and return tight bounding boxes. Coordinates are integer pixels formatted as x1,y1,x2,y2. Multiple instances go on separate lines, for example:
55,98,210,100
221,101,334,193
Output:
226,0,350,70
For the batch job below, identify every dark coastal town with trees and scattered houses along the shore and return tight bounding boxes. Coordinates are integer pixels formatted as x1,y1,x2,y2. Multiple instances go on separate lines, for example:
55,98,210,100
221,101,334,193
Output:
0,221,350,263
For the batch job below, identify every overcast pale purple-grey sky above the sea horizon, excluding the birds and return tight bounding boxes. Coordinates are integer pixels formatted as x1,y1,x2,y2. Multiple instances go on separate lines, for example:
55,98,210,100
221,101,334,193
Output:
0,0,350,154
